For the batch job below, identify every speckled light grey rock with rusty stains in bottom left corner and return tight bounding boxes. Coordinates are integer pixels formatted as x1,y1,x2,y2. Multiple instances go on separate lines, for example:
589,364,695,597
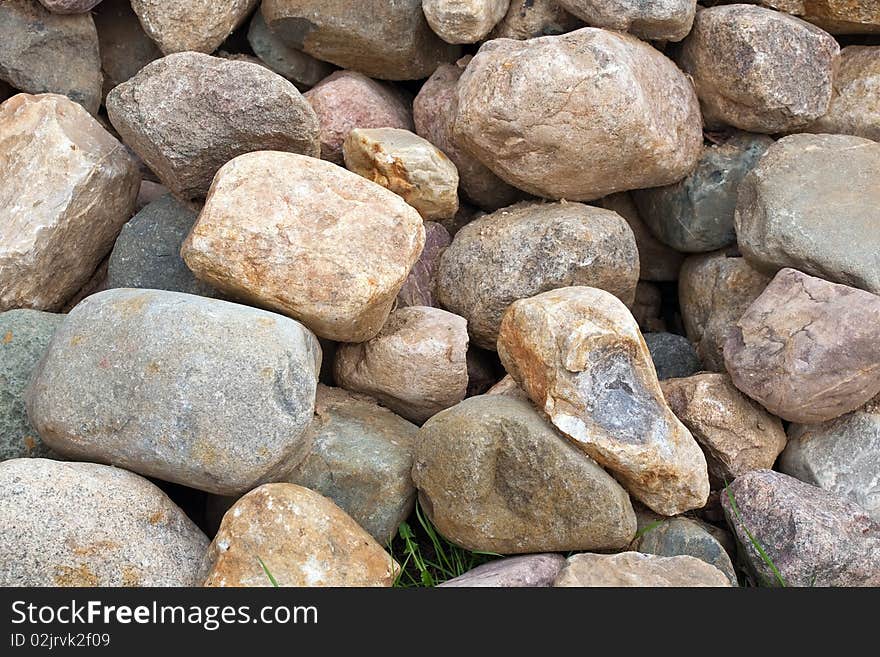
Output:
0,459,208,586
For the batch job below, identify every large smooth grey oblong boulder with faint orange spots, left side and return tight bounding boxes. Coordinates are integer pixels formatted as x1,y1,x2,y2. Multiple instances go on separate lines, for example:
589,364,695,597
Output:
27,289,321,495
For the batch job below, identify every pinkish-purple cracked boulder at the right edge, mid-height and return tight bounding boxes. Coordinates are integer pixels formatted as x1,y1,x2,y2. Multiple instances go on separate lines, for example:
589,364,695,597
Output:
724,269,880,422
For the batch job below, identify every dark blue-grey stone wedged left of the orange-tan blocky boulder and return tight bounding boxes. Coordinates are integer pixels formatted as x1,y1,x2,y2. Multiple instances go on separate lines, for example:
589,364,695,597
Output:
107,194,218,297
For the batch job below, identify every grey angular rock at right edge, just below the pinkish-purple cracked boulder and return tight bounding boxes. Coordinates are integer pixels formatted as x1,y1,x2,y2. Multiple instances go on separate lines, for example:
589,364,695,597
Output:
784,398,880,522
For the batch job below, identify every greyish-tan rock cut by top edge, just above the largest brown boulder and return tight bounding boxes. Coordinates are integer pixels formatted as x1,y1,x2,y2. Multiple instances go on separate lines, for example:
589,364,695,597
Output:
554,0,697,41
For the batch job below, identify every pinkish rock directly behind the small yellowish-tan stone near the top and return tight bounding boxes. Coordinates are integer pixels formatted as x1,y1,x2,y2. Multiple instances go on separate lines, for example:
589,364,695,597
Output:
305,71,416,165
